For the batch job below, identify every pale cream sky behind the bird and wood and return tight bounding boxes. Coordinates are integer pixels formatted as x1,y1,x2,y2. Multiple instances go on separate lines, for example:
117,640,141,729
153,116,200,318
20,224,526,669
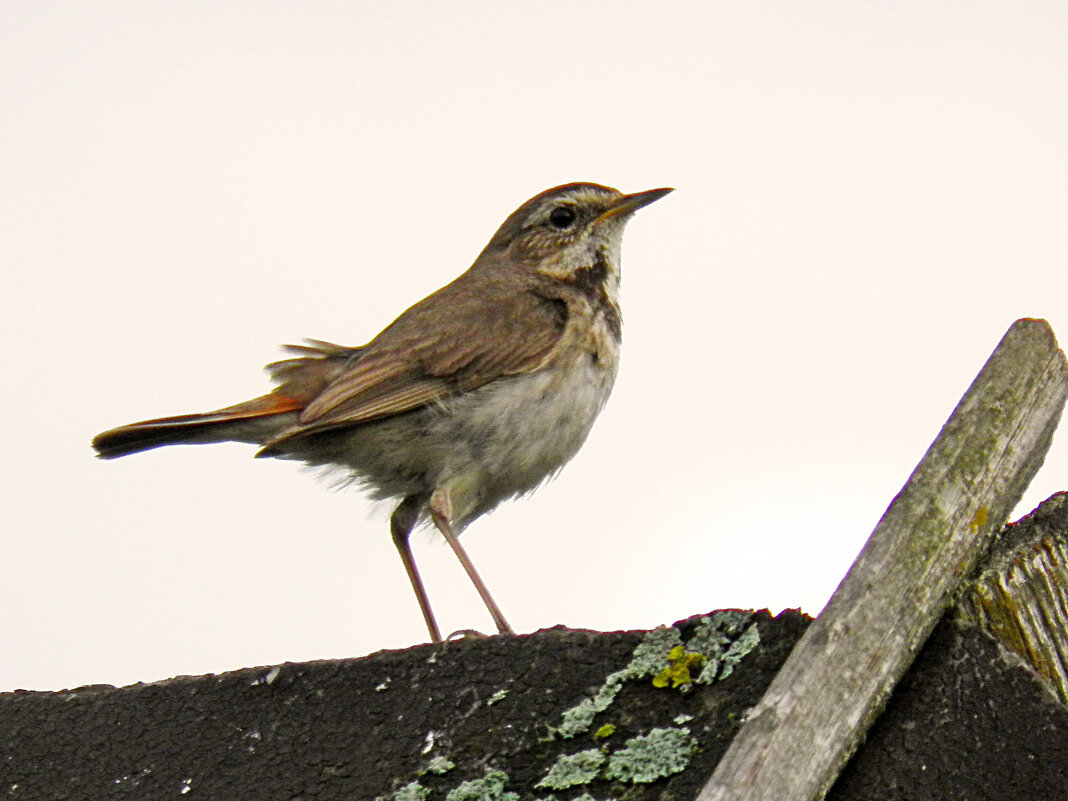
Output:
0,0,1068,690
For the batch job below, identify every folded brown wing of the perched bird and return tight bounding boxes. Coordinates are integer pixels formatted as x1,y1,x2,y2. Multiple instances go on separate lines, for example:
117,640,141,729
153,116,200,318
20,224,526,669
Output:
268,285,566,445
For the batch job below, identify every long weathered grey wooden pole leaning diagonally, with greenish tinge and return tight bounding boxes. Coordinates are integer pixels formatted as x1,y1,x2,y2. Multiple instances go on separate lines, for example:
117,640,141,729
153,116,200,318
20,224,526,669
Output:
698,319,1068,801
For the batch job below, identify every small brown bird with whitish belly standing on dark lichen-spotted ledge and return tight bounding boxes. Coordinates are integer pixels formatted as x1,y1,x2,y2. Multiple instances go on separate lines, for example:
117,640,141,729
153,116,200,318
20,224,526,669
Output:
92,183,673,642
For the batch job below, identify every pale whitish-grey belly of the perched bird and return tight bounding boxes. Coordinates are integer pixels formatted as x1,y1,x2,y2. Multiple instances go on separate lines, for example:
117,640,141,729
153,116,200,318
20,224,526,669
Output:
299,351,616,530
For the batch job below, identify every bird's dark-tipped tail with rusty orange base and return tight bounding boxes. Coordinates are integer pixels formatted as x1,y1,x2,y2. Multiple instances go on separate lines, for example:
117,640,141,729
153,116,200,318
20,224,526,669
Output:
93,392,303,459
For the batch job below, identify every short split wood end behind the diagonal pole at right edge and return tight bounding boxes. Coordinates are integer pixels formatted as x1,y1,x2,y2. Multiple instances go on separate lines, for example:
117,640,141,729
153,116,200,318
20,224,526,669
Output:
957,492,1068,705
